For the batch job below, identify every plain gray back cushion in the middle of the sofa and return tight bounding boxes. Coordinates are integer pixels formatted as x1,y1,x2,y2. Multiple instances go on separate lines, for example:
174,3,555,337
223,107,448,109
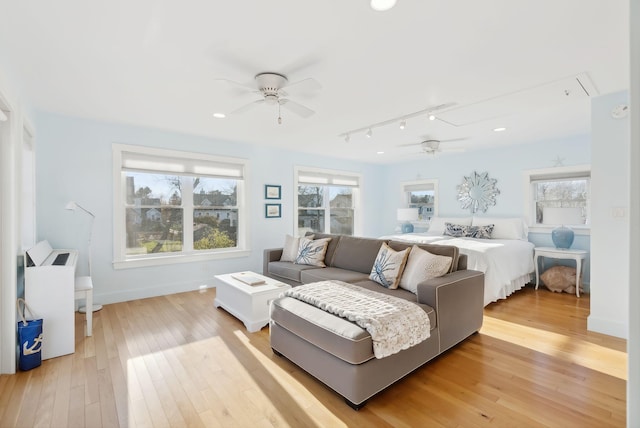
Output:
329,235,386,274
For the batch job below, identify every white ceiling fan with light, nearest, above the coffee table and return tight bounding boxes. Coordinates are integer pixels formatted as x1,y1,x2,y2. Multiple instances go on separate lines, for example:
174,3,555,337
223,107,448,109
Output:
218,72,321,124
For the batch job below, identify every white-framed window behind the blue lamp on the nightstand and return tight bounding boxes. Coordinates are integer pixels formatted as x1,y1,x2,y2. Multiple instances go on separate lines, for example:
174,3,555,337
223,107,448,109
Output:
525,165,591,228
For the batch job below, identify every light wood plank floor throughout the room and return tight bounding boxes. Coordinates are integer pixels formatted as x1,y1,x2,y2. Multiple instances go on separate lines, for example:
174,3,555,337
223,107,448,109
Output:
0,287,626,427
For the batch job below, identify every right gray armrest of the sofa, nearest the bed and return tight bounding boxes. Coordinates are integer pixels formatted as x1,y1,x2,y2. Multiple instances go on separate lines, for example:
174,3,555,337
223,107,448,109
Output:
418,270,484,352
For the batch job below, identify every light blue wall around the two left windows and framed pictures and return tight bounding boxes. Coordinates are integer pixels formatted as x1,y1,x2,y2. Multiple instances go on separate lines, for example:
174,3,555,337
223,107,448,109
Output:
36,112,383,303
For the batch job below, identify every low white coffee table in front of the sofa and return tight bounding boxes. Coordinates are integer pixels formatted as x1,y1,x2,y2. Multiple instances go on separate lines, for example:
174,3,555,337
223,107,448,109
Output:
213,271,291,333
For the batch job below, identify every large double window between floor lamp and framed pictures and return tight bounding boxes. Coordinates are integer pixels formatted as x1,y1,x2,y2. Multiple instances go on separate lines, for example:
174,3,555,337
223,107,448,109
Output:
114,145,246,267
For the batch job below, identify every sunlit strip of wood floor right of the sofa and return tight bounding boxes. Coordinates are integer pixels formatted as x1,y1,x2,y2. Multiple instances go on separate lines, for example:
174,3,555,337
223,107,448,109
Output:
480,316,627,380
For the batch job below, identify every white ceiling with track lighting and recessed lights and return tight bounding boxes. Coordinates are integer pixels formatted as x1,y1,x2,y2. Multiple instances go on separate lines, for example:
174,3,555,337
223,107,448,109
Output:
0,0,629,163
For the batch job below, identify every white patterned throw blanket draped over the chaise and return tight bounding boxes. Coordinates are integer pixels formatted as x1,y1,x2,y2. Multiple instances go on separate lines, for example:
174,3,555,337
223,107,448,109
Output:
284,281,431,358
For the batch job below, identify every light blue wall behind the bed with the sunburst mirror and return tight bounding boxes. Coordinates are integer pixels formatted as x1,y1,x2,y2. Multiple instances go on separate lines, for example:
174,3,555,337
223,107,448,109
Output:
383,136,591,291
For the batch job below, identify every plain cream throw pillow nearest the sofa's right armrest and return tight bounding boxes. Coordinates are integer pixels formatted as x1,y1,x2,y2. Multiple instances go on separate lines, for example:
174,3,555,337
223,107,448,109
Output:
400,245,451,293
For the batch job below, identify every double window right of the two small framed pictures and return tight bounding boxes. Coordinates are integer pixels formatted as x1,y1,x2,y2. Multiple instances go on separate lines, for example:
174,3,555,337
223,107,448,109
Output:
295,168,361,236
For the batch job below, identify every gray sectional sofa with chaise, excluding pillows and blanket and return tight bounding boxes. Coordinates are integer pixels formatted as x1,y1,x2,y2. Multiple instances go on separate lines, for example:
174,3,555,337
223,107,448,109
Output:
263,233,484,409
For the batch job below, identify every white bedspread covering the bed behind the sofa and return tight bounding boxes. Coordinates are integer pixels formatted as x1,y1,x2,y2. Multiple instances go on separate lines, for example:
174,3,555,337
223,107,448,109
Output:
381,232,534,306
